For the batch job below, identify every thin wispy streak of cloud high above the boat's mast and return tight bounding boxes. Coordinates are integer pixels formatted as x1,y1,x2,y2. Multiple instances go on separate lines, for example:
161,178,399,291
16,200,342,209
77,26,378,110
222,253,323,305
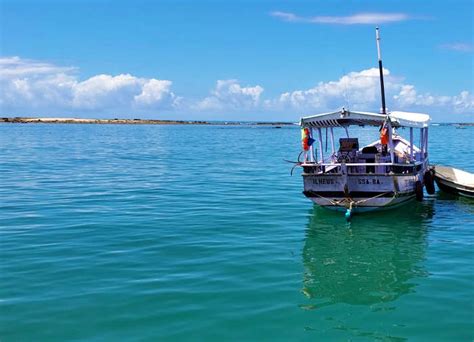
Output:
270,11,411,25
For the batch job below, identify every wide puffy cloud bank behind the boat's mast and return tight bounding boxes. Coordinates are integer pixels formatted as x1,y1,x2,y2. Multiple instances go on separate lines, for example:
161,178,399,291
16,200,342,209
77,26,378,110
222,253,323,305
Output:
274,68,474,114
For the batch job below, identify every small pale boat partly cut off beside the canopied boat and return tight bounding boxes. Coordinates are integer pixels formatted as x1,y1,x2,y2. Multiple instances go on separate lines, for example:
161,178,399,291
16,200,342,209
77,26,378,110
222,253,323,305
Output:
434,165,474,198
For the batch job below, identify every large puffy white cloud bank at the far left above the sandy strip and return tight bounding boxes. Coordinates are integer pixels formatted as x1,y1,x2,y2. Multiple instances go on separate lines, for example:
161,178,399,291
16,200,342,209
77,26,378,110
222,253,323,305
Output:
0,57,179,114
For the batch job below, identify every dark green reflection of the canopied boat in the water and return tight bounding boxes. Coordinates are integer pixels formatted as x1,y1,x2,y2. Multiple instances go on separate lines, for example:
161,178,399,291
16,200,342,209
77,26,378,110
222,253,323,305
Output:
302,202,433,308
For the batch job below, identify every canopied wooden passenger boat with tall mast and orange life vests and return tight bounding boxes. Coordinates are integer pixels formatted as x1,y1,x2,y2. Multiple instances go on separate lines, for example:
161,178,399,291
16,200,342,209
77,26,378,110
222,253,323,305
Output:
297,28,435,219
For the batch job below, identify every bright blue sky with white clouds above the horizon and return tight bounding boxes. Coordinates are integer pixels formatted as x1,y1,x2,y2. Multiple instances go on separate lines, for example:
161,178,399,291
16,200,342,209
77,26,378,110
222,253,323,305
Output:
0,0,474,121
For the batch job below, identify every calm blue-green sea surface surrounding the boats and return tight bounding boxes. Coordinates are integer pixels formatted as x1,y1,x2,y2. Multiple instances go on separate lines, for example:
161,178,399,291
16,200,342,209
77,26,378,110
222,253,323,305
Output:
0,124,474,342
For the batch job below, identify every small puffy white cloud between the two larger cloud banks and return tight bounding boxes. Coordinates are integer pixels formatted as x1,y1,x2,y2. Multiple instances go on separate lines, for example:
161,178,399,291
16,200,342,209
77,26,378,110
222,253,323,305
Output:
195,80,264,110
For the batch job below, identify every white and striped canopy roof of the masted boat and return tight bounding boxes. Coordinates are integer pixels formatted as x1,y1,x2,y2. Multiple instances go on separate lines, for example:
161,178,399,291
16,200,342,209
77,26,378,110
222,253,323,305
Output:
300,109,430,128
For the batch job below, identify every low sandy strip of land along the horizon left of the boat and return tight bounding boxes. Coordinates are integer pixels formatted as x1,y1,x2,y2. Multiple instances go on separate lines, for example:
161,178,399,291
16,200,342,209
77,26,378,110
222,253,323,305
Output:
0,117,294,127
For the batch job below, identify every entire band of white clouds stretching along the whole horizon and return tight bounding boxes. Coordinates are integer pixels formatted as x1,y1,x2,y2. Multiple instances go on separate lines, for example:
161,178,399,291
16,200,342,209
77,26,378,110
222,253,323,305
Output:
0,57,474,120
